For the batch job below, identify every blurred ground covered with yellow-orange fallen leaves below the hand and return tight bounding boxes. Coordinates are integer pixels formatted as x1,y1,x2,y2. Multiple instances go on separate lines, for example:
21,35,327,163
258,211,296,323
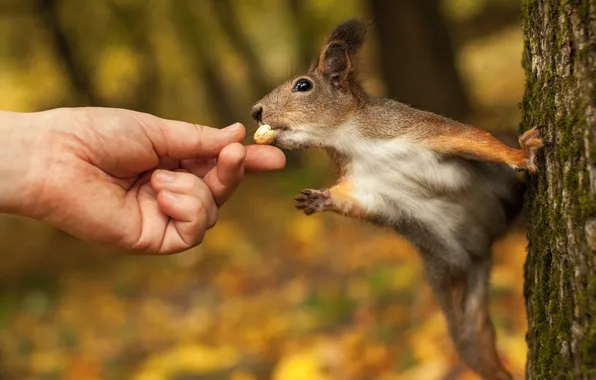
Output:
0,170,526,380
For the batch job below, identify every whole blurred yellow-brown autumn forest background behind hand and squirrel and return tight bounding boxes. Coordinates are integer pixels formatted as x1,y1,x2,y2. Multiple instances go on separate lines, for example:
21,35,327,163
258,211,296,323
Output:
0,0,526,380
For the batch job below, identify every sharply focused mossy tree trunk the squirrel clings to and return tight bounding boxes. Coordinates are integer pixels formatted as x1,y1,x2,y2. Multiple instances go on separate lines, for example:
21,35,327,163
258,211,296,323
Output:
521,0,596,379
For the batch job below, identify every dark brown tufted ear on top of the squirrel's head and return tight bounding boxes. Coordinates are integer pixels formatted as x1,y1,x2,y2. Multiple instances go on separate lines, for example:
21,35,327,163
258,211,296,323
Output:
316,19,367,88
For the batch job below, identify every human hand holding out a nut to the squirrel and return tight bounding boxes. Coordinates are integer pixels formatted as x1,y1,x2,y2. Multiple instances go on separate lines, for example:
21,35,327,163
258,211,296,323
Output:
0,108,285,254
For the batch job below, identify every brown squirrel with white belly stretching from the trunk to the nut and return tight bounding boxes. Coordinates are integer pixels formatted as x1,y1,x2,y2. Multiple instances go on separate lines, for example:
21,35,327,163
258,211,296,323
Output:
252,19,544,380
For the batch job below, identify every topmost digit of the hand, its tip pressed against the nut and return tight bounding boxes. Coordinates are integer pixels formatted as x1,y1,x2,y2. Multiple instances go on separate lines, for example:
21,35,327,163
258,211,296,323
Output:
145,118,246,160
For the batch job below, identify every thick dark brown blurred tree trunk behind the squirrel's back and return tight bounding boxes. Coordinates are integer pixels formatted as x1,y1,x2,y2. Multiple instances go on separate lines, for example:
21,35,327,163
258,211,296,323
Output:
369,0,470,119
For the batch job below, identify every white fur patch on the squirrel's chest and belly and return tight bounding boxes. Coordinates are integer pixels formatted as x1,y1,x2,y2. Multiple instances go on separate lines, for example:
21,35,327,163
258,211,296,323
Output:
336,135,469,237
